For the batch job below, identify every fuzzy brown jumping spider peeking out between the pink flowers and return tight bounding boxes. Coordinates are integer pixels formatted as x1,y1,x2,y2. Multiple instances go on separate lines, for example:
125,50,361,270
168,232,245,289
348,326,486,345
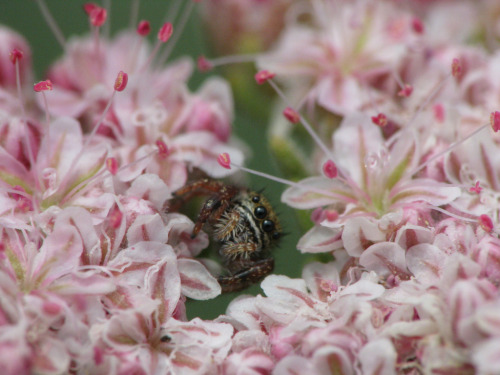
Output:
174,178,281,293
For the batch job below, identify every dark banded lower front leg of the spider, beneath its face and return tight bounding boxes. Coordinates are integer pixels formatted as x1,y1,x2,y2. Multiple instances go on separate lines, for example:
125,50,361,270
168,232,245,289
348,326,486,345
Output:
218,257,274,293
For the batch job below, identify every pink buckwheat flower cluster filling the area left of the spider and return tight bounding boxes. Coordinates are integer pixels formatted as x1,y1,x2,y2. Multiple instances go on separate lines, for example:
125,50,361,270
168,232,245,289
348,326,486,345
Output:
0,3,242,374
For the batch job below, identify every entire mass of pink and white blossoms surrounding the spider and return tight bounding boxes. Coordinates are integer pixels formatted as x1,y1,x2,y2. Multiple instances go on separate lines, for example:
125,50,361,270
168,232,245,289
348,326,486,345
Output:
0,0,500,375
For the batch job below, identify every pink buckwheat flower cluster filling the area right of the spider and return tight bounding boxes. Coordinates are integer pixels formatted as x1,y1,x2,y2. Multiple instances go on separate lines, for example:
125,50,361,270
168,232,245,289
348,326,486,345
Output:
201,0,500,375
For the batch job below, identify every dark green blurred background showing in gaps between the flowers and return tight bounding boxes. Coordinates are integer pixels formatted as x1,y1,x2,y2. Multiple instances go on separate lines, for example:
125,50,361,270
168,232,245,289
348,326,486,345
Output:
0,0,306,319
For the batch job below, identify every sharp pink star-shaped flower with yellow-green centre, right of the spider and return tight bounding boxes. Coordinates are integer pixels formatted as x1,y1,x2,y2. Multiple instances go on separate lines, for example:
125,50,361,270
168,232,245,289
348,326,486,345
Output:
282,115,460,252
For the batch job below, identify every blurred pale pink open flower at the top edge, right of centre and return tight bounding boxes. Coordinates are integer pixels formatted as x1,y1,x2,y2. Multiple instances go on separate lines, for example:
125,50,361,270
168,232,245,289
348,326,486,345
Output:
258,1,416,114
